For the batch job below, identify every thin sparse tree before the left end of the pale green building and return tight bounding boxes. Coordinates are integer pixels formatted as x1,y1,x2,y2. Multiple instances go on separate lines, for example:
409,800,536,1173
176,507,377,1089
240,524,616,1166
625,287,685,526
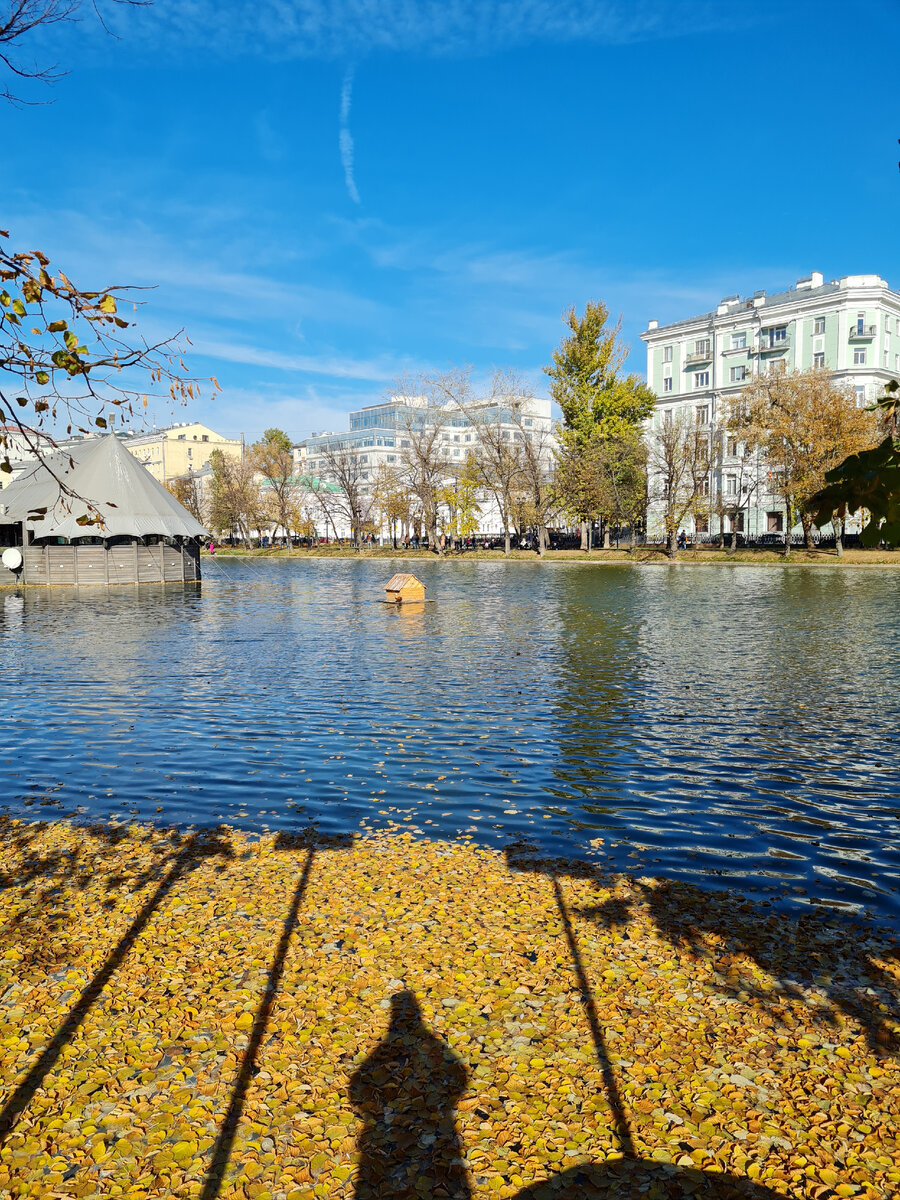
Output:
647,413,709,558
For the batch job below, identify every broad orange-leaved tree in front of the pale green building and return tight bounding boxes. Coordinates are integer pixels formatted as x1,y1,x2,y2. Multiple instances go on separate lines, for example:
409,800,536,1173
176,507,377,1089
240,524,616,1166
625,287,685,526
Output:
736,368,877,557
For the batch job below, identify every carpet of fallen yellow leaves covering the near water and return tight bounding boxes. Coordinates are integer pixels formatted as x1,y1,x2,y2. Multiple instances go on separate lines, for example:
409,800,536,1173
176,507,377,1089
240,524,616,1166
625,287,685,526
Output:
0,820,900,1200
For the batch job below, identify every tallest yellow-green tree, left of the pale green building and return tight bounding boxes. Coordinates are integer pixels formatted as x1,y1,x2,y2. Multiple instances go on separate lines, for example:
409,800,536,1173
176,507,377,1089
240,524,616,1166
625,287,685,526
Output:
544,300,656,550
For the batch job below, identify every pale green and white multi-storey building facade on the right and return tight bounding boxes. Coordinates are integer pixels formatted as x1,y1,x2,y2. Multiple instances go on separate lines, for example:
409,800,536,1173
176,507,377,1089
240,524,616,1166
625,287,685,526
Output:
641,271,900,536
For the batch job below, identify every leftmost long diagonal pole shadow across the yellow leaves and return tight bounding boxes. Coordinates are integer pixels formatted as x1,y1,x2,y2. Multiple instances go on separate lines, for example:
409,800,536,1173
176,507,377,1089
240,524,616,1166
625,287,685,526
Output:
0,830,232,1147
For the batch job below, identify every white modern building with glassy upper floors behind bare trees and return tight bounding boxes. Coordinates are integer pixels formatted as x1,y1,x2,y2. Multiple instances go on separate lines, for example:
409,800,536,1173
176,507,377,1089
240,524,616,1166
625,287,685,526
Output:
294,396,556,536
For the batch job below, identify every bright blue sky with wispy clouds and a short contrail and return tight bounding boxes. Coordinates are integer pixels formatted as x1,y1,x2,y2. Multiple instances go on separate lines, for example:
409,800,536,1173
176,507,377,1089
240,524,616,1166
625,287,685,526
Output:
7,0,900,438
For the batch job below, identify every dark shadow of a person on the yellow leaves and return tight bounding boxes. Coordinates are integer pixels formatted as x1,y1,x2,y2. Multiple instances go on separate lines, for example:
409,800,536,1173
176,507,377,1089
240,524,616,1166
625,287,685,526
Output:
350,991,472,1200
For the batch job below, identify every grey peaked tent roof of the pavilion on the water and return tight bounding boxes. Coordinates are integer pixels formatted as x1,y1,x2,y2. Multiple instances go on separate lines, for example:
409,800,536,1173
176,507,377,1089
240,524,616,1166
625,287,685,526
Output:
0,433,206,538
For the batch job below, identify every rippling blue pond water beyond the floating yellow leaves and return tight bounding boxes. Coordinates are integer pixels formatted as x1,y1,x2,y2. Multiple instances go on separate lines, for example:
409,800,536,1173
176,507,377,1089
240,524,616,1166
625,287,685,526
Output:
0,559,900,920
